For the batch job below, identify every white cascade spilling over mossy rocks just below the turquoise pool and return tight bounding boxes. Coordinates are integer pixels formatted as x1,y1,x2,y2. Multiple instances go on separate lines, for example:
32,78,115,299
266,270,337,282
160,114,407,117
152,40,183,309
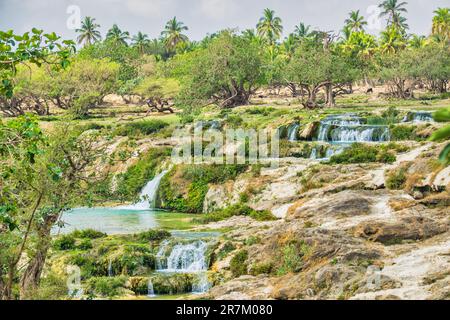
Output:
156,240,211,293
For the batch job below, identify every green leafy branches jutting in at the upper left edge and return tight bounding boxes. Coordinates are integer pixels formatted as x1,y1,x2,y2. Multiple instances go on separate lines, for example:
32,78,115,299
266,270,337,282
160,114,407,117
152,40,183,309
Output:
0,28,75,100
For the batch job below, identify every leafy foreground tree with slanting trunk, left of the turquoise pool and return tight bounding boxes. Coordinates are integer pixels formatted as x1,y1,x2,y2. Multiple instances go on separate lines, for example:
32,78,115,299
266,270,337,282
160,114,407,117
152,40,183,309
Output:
0,116,104,300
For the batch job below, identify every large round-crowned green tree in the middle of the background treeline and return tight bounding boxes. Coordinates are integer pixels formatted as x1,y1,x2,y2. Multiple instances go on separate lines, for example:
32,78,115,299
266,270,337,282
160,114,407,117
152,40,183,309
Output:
180,32,264,107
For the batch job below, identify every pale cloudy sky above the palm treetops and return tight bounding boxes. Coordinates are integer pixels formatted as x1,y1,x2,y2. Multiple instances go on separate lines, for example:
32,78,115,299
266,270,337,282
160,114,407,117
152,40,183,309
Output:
0,0,450,40
